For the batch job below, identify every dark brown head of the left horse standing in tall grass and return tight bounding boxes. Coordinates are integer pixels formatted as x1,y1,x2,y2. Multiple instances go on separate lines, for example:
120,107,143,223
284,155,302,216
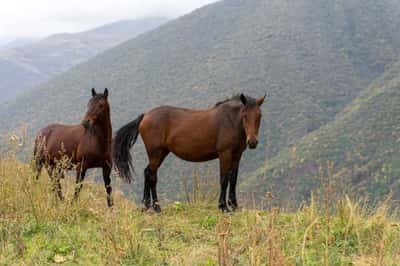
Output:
82,88,110,128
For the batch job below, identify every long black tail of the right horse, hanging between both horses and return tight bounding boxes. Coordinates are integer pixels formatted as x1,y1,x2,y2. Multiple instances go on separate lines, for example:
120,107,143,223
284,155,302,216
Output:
113,114,144,183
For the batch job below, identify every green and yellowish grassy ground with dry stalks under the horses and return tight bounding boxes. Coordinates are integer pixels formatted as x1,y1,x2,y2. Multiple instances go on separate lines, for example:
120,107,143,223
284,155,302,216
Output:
0,155,400,265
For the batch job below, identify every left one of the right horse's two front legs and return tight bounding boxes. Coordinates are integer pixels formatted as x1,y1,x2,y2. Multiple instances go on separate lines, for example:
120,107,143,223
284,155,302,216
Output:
218,152,234,212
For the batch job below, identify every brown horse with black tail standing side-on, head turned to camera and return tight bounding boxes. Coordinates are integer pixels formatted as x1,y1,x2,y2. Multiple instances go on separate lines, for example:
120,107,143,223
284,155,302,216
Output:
113,94,265,212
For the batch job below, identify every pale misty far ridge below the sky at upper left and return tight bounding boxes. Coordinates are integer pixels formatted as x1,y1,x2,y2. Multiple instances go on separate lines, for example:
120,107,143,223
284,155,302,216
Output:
0,18,167,102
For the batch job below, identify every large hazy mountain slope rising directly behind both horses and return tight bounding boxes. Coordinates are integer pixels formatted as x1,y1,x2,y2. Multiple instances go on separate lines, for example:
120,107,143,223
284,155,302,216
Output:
0,0,400,202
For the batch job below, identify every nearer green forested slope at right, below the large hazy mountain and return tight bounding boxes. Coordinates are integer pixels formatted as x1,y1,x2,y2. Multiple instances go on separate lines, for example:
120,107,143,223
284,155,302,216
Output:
244,62,400,205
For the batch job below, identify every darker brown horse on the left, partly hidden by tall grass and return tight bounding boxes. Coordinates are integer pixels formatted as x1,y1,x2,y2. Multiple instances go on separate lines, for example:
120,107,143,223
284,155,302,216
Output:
34,89,113,207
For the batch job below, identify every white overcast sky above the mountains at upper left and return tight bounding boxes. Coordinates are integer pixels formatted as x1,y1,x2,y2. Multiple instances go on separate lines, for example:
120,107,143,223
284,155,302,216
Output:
0,0,216,40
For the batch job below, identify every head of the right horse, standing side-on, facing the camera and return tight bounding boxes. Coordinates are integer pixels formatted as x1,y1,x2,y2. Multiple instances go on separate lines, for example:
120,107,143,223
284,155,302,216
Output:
240,94,265,149
